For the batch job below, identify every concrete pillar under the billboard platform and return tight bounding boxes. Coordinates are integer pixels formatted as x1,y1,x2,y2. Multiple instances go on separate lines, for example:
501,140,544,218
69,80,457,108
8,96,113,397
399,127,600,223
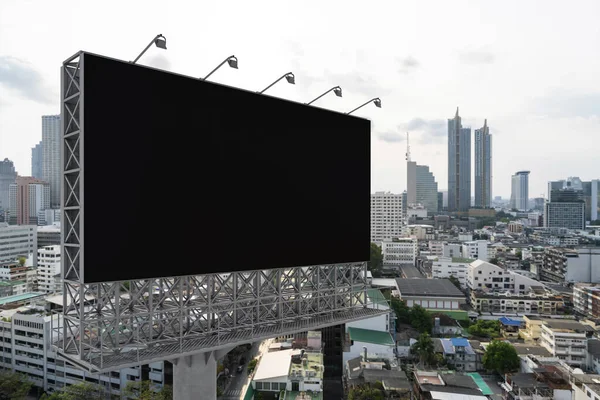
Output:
171,348,232,400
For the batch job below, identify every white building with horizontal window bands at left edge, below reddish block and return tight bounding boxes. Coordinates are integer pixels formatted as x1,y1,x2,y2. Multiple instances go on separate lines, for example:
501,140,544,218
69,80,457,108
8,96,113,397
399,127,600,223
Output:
0,222,37,266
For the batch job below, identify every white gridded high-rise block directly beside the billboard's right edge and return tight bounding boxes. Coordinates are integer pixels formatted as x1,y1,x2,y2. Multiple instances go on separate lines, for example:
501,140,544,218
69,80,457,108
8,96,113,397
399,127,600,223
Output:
371,192,402,244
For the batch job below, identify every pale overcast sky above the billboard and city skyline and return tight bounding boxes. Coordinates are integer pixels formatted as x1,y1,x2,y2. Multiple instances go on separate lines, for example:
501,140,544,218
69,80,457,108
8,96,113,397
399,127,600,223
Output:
0,0,600,198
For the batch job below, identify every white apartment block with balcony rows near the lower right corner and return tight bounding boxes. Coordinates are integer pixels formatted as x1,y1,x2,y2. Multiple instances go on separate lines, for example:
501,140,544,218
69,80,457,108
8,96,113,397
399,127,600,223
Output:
540,319,594,368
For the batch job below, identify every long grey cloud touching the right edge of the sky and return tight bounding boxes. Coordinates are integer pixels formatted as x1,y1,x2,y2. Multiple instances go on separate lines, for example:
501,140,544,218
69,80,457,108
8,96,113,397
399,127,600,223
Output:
532,88,600,118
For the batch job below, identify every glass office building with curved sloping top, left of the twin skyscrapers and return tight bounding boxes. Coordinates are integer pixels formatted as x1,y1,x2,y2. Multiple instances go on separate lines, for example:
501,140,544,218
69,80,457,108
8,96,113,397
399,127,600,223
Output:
406,161,438,214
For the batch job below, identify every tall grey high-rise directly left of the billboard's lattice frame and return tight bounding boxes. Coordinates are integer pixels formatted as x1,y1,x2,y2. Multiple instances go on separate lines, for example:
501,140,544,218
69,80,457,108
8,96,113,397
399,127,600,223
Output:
42,115,61,208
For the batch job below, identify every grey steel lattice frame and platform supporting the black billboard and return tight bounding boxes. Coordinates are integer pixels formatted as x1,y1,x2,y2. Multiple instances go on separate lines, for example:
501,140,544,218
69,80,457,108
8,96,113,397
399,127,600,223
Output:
52,52,389,372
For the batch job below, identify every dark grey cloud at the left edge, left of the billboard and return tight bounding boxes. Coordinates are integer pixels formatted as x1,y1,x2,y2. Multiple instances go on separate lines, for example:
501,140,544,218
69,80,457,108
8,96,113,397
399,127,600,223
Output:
0,56,54,104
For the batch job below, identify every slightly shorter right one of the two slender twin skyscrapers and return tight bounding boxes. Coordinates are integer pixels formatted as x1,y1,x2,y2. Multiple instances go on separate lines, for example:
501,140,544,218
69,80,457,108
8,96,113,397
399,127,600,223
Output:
475,119,492,208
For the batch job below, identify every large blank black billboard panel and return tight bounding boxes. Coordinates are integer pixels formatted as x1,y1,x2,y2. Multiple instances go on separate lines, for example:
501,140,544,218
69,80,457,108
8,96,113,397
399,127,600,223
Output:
81,53,371,283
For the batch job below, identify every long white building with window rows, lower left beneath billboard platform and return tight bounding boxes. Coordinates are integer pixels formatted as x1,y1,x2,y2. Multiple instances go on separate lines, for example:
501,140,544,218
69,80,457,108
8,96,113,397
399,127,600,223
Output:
0,306,172,395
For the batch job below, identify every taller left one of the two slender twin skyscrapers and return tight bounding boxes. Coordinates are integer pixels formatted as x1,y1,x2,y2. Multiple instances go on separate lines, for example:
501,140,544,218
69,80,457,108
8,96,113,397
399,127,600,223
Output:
448,108,471,211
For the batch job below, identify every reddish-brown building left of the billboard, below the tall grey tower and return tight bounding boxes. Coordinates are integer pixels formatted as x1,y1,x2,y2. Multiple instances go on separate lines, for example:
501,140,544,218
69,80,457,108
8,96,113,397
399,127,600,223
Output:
9,176,50,225
